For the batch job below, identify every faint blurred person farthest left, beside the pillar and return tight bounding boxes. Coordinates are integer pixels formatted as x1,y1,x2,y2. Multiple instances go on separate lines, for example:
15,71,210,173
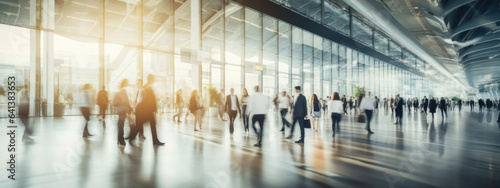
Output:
17,84,34,142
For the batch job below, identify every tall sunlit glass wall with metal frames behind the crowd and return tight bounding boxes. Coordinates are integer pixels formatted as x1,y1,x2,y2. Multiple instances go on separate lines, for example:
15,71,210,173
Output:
0,0,458,117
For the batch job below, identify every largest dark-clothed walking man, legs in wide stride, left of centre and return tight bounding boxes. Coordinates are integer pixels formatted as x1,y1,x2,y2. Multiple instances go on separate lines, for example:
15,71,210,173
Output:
128,75,165,146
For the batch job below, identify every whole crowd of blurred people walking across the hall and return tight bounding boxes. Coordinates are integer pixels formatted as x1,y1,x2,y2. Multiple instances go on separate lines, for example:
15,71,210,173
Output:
14,75,500,147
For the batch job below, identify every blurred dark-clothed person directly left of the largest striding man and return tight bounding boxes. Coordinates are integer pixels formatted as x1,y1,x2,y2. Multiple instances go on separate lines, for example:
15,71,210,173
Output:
113,79,132,146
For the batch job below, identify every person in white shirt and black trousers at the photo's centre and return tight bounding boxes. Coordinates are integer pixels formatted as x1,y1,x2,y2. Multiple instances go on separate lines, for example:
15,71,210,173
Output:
246,86,270,147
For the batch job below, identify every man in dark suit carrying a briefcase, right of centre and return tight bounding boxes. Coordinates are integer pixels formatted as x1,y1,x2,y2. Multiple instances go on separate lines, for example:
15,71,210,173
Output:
287,86,307,144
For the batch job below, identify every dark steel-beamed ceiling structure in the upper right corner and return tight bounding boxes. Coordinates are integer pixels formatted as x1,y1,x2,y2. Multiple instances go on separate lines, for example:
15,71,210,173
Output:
377,0,500,87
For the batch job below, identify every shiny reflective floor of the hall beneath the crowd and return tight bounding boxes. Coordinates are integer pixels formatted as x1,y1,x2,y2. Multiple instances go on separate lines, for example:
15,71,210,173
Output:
0,110,500,188
